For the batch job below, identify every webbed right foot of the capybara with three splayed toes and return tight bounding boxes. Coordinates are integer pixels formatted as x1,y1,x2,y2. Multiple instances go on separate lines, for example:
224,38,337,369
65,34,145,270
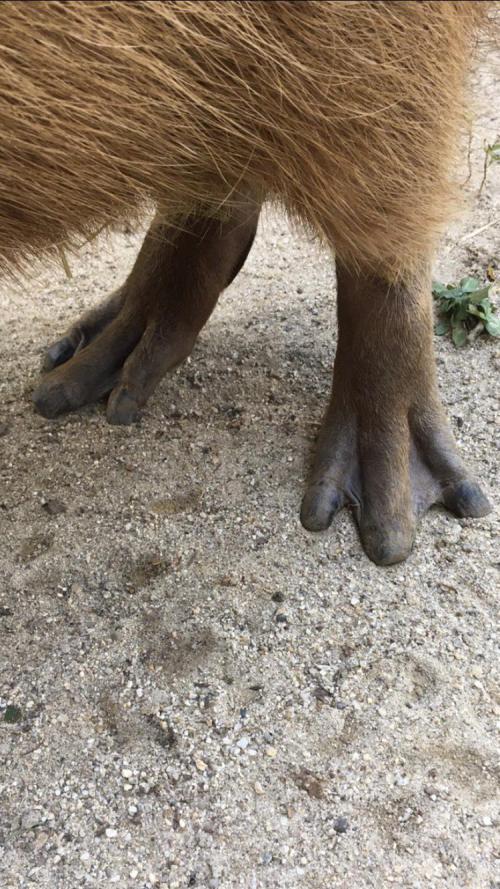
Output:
300,405,491,565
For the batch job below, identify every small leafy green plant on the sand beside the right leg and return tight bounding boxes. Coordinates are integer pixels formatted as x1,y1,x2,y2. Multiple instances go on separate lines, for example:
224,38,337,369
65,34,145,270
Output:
432,278,500,347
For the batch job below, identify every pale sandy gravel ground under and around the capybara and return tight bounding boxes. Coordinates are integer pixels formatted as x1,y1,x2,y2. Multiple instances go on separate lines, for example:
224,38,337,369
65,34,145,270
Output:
0,46,500,889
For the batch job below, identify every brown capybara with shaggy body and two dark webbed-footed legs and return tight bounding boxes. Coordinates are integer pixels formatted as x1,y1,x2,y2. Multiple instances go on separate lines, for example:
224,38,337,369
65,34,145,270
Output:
0,0,495,564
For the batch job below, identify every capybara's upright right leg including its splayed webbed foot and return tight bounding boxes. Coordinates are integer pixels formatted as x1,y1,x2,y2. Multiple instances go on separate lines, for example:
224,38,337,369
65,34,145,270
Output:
301,265,490,565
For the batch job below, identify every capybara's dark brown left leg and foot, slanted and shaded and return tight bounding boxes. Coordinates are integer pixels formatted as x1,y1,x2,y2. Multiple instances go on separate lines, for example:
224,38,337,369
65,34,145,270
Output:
33,202,259,423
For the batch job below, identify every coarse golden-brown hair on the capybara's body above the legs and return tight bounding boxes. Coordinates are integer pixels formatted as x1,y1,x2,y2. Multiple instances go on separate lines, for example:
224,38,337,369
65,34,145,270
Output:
0,0,491,277
